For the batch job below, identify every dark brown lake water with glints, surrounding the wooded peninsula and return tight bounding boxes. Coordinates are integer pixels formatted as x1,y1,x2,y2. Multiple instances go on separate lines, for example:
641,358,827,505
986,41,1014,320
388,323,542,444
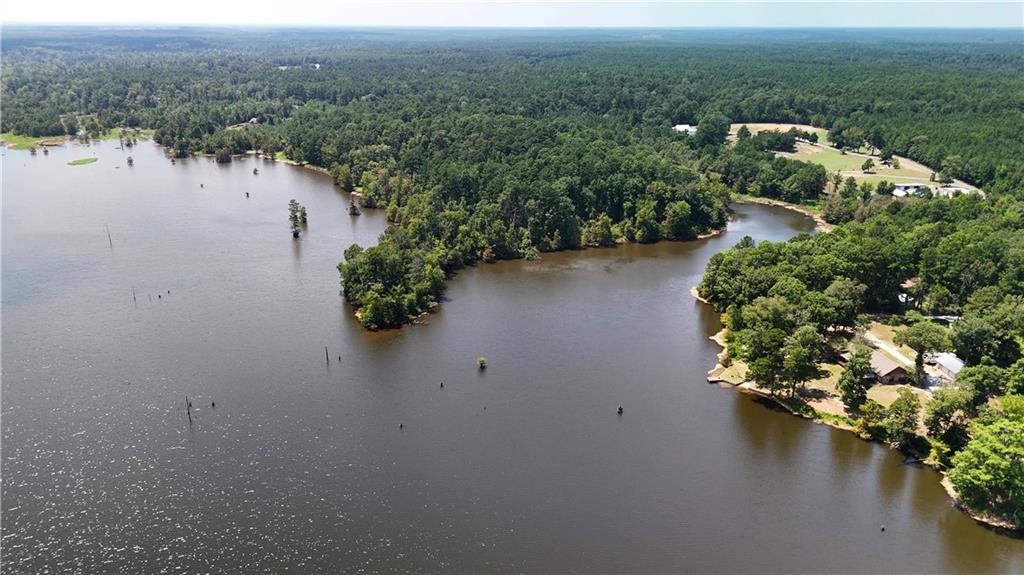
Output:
2,138,1024,573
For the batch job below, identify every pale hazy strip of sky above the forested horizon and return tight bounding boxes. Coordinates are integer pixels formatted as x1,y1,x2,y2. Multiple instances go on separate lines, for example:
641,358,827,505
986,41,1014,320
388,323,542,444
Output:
0,0,1024,31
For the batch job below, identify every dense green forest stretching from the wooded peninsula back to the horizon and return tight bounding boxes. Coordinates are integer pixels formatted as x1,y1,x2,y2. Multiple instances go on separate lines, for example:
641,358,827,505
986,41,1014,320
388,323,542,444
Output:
2,29,1024,327
